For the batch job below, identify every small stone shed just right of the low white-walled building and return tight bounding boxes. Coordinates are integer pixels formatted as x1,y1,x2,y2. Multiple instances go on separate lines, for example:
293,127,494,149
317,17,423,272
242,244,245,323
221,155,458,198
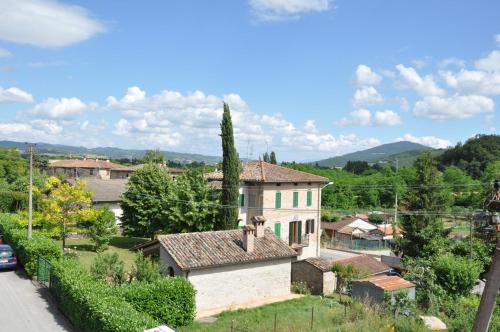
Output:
292,257,337,295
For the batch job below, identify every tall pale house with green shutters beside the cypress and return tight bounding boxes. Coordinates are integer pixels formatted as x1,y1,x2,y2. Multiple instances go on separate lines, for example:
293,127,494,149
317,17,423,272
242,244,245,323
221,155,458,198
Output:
207,161,328,259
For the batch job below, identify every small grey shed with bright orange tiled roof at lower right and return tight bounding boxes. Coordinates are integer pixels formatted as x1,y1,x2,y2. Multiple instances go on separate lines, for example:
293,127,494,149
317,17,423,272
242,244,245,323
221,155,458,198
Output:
352,275,415,303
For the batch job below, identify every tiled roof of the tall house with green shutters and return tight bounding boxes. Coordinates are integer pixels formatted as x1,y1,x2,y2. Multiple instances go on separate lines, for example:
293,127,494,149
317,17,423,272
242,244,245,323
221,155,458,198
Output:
206,161,328,183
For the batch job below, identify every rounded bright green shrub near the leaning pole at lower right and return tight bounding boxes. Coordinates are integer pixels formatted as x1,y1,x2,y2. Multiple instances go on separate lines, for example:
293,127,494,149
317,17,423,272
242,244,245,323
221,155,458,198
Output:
431,254,481,296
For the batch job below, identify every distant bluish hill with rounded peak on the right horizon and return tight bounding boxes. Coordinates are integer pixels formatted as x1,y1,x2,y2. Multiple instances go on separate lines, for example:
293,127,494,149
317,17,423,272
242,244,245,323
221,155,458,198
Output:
312,141,440,167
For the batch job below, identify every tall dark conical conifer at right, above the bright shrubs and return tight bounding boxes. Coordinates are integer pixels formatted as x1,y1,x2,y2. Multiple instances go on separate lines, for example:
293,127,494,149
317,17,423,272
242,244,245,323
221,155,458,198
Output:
399,152,452,257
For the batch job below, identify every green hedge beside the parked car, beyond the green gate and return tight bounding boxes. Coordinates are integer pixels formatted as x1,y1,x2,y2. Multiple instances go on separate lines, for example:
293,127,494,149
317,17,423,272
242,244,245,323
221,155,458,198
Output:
0,214,63,277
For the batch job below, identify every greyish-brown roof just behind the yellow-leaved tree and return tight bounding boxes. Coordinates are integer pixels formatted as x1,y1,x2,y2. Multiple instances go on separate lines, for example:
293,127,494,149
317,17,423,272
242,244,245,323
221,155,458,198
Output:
68,178,128,203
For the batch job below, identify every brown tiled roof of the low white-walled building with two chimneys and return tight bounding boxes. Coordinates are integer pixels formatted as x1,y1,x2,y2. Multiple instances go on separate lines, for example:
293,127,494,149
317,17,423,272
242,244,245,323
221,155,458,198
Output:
157,229,297,270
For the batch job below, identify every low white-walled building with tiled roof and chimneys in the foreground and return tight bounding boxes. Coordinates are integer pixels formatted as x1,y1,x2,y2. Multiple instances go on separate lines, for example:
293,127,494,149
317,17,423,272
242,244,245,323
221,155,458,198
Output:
136,218,297,317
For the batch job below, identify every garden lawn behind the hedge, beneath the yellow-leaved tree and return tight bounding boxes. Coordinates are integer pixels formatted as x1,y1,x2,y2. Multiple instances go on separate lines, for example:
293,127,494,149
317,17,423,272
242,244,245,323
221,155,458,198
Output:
66,236,148,270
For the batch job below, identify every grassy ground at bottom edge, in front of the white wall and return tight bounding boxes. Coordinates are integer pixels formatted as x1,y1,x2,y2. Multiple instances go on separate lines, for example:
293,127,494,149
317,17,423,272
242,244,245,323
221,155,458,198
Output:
179,296,419,332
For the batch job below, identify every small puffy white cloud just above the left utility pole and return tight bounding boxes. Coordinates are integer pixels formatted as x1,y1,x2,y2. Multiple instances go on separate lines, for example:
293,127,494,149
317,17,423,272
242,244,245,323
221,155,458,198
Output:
26,97,88,119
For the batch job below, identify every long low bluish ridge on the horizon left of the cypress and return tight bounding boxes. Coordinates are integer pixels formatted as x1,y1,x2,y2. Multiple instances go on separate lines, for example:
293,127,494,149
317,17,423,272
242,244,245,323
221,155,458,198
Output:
0,141,222,165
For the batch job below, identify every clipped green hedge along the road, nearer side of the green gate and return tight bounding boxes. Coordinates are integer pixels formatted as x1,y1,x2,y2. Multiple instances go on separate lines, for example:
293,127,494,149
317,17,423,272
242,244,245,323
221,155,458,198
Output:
51,260,159,332
